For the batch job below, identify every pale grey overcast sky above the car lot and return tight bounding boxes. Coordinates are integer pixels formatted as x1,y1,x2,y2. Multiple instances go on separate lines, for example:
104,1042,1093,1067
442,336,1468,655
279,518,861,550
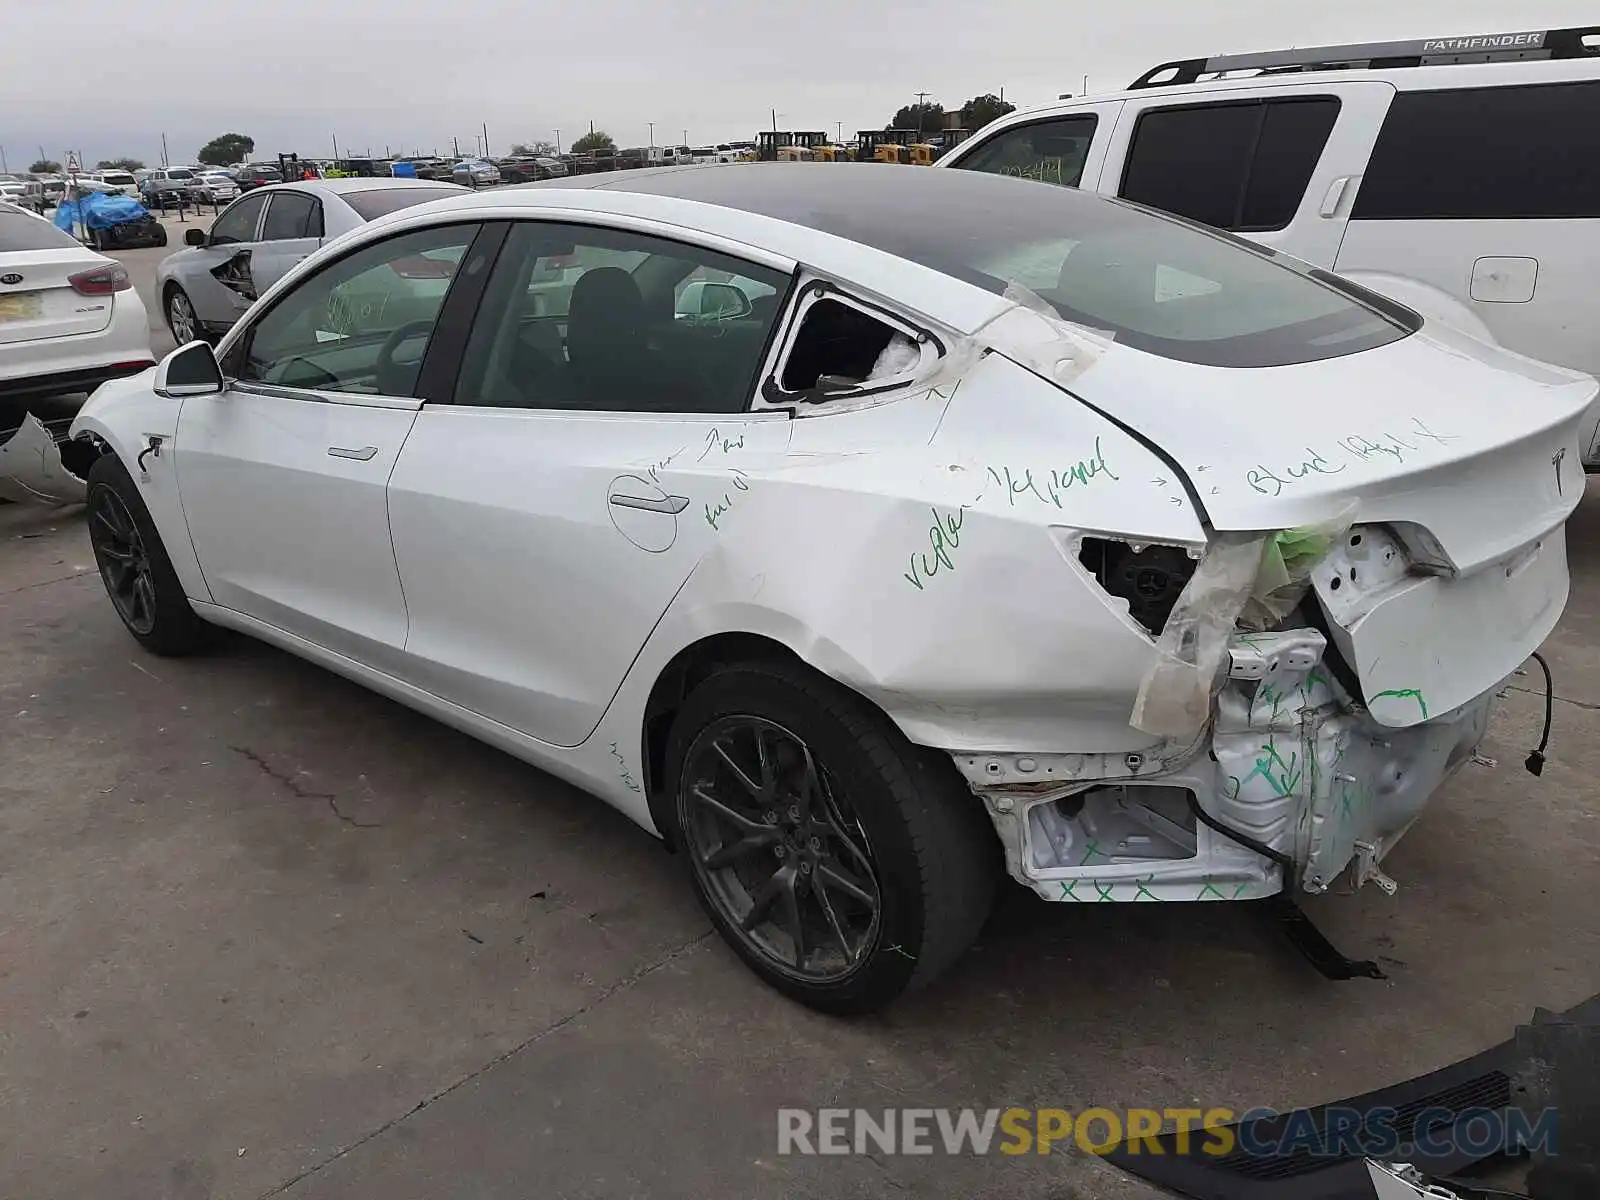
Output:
0,0,1594,171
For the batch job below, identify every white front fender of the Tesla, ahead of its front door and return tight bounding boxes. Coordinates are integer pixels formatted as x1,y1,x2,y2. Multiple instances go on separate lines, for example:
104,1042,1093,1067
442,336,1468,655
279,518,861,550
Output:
70,376,216,603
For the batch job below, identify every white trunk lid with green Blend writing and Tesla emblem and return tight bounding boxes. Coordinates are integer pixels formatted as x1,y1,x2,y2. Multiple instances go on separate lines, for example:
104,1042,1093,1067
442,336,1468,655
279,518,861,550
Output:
992,315,1600,726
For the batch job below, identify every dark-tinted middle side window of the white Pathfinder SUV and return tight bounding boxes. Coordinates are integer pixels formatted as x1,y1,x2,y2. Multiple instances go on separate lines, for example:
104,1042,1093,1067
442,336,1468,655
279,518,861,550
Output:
1122,96,1339,232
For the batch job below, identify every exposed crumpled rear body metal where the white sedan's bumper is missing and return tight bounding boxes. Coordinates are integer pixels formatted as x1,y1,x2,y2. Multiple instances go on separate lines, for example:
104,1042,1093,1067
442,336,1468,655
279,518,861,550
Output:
955,629,1494,908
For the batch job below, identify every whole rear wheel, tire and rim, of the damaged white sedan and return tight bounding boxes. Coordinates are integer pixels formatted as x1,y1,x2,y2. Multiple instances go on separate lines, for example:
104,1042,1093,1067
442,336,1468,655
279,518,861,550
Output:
666,662,1000,1013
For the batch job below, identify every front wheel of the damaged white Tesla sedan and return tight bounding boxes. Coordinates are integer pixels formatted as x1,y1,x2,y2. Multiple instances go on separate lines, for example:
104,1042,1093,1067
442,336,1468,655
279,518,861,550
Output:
88,454,213,656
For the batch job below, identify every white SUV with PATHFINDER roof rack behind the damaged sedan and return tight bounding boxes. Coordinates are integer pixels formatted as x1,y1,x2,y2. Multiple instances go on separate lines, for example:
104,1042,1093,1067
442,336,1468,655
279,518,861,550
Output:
938,26,1600,469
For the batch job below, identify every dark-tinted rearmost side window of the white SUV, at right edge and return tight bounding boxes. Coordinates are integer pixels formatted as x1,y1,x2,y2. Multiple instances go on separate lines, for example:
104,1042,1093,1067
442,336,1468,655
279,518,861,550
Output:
1350,82,1600,221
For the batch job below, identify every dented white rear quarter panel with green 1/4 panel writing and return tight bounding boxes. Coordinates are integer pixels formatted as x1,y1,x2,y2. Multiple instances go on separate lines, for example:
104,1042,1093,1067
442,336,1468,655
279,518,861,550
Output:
621,355,1205,752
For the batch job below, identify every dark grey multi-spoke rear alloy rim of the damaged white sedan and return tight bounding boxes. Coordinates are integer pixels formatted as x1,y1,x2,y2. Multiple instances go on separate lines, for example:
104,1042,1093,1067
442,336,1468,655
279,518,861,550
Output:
678,715,883,982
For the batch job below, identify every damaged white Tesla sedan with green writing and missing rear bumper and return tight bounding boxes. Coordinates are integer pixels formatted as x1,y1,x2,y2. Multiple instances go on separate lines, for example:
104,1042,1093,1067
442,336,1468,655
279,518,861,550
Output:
74,163,1595,1011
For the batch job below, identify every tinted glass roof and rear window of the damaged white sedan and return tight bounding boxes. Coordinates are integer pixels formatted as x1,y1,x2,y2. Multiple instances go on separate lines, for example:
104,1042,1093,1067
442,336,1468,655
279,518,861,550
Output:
608,163,1414,366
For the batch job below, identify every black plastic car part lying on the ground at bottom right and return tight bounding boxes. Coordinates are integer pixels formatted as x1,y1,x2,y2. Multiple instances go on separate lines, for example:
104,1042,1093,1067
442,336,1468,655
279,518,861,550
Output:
1104,995,1600,1200
